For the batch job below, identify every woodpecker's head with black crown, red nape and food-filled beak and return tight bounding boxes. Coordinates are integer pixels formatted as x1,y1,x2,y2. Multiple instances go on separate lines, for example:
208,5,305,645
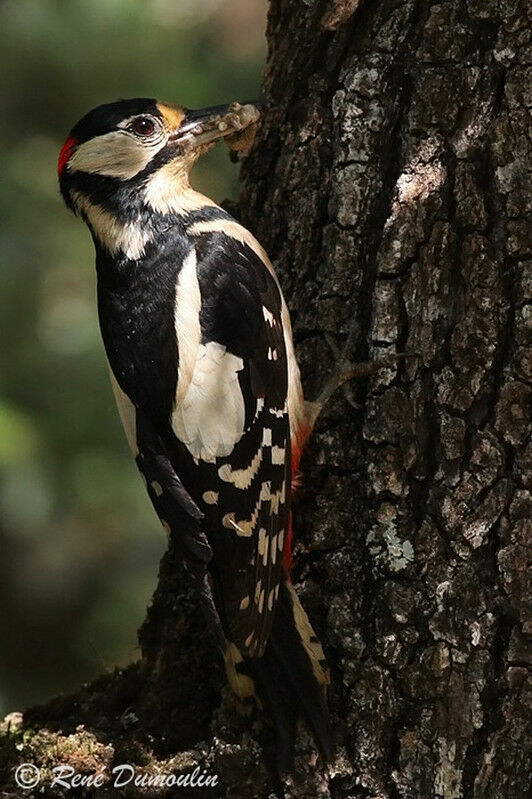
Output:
58,98,259,260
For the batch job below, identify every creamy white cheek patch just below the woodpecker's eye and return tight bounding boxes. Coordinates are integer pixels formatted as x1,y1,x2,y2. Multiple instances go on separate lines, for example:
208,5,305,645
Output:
68,130,166,180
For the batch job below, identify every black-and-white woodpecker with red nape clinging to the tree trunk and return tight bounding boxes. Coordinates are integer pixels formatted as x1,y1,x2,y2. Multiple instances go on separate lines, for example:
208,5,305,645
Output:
58,99,366,767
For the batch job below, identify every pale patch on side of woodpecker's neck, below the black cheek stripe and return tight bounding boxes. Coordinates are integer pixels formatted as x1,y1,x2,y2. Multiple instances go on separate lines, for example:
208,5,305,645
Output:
71,191,152,261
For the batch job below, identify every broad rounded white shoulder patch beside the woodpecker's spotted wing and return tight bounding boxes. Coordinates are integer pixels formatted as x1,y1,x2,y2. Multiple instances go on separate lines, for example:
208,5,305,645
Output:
172,341,245,463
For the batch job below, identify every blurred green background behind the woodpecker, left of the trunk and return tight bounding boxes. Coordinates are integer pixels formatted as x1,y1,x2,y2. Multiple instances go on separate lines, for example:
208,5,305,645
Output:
0,0,266,714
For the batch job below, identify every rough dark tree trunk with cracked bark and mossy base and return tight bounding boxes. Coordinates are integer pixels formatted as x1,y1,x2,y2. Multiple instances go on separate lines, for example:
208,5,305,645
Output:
3,0,532,799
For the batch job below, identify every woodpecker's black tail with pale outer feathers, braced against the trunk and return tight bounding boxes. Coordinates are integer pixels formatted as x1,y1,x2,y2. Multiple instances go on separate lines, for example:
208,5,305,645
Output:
226,582,332,771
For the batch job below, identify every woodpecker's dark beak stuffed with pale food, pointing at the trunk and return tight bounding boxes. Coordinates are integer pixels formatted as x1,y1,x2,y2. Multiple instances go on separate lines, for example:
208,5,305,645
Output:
172,100,264,149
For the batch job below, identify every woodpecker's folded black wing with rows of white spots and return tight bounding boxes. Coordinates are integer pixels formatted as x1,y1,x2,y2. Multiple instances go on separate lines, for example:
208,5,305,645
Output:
171,232,291,656
